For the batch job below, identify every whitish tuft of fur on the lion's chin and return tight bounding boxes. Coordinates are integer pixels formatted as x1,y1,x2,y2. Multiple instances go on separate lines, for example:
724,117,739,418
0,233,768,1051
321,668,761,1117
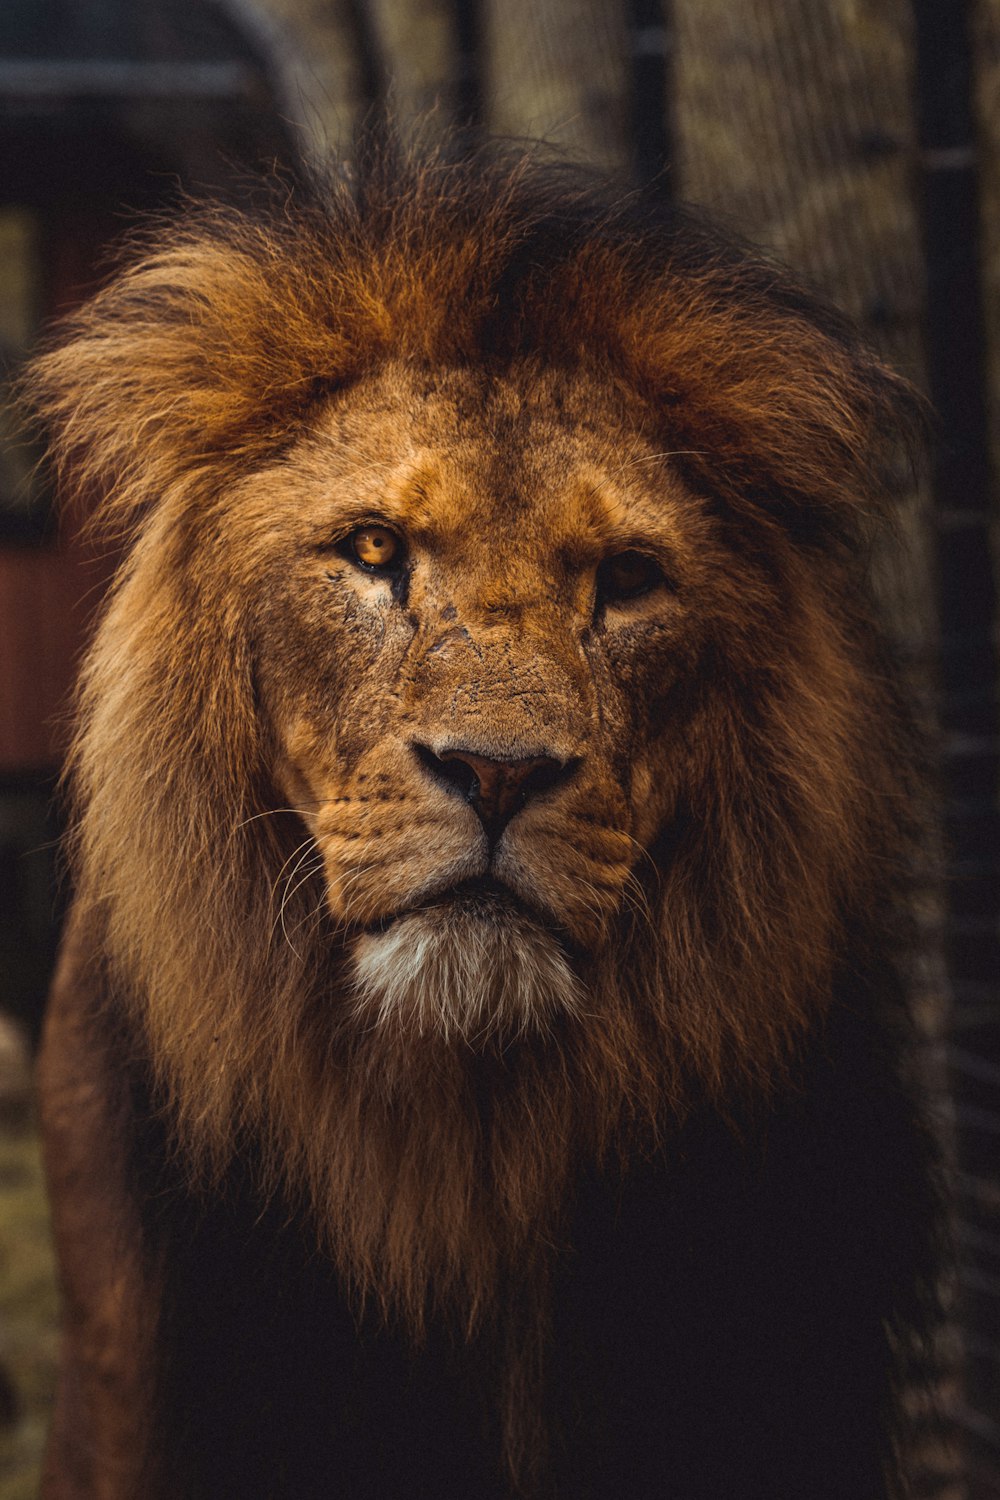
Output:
352,905,580,1043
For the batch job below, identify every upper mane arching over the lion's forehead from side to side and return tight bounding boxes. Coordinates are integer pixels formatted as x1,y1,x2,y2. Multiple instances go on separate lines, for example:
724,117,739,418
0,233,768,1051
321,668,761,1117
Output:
28,141,922,546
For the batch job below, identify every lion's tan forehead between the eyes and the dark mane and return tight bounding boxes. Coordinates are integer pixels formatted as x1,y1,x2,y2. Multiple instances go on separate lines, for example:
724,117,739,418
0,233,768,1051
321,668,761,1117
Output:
277,368,684,567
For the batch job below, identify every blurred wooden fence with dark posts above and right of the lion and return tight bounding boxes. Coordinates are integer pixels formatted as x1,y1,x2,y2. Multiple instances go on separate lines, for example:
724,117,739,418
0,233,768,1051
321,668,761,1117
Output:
260,0,1000,1500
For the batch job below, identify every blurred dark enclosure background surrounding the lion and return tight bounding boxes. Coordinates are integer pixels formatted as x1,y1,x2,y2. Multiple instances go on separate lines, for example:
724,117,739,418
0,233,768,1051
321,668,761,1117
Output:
0,0,1000,1500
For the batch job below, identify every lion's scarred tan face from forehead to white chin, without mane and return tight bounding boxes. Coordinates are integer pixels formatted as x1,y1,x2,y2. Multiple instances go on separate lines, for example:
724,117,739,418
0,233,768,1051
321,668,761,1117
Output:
235,368,711,1032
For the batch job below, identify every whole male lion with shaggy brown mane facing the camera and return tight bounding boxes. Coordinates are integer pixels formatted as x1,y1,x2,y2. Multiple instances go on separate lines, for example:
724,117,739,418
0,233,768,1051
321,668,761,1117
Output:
31,149,937,1500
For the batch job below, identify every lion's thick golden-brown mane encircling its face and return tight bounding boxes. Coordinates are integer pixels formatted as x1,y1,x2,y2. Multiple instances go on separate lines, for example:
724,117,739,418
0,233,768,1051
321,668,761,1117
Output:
33,143,941,1500
